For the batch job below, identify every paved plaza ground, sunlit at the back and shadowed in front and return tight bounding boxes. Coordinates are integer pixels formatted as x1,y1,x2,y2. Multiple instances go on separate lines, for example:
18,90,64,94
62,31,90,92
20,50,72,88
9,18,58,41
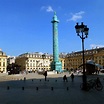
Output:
0,73,104,104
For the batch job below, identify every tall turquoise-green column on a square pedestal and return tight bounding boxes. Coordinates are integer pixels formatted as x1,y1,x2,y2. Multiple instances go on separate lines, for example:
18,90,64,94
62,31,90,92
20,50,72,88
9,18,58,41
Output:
51,12,62,72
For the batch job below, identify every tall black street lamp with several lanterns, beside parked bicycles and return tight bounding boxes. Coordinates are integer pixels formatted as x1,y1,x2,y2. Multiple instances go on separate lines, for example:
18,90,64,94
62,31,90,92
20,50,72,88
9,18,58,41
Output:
75,22,89,90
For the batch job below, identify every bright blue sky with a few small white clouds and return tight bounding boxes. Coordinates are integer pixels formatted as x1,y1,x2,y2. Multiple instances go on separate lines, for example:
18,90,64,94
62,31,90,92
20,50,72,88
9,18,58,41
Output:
0,0,104,56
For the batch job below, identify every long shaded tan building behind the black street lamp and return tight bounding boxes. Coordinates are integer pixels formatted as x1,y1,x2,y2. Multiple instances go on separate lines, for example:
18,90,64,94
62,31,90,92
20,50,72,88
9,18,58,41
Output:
65,48,104,69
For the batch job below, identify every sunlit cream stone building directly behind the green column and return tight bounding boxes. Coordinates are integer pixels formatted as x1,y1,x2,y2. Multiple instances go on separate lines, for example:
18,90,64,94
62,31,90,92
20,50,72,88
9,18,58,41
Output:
15,52,65,71
